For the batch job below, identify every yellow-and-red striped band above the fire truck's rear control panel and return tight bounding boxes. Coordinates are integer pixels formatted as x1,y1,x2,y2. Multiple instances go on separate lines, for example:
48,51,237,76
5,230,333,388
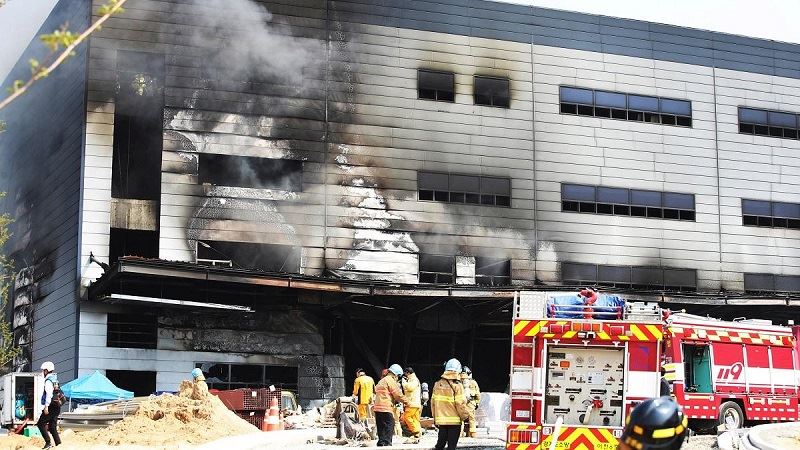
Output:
514,320,664,342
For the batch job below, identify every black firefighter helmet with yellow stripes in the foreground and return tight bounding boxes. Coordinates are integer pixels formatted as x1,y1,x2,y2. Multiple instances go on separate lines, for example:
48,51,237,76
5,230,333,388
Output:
618,397,688,450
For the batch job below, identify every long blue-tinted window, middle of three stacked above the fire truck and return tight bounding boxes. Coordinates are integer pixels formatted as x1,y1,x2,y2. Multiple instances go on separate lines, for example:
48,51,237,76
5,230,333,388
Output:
561,183,695,221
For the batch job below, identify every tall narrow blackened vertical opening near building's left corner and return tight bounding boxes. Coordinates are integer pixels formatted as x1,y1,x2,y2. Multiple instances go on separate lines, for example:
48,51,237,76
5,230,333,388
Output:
111,50,164,200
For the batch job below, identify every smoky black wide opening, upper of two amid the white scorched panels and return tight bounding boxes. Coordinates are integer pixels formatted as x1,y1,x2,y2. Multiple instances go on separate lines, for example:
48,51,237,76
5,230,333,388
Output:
198,153,303,192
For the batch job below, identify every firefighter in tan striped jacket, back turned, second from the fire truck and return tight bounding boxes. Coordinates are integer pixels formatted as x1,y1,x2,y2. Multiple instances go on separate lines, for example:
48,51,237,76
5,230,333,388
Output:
431,358,469,450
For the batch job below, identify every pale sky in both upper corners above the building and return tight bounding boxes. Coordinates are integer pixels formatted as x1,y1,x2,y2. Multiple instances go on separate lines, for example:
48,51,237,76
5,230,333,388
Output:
0,0,800,85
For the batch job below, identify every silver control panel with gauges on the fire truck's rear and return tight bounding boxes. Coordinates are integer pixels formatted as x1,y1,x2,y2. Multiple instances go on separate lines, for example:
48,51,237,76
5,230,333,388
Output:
544,346,625,427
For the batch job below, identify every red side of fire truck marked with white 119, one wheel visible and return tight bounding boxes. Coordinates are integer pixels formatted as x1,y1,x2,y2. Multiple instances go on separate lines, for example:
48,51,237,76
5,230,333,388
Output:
663,313,800,429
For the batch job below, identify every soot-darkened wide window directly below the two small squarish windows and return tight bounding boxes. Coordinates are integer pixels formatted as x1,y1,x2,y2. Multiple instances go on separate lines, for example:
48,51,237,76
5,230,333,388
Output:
417,171,511,206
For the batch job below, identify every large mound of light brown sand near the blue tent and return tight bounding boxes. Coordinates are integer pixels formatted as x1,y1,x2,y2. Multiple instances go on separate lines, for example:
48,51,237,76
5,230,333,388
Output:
70,381,259,447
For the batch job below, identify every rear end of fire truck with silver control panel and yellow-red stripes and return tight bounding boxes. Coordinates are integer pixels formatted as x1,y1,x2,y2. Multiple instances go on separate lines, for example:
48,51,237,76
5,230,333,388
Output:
506,292,663,450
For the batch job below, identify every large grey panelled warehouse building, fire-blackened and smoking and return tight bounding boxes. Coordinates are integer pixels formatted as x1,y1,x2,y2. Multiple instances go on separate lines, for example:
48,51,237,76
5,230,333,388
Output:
0,0,800,401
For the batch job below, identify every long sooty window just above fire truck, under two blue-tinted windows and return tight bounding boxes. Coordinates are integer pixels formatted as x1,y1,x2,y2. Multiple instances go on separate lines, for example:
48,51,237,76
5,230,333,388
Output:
561,262,697,291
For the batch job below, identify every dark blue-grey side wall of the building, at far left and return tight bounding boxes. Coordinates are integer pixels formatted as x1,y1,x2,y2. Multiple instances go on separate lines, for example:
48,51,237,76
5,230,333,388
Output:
0,0,90,381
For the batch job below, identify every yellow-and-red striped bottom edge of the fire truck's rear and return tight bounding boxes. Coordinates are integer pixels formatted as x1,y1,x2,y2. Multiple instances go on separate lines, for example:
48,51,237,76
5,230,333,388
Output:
506,425,618,450
